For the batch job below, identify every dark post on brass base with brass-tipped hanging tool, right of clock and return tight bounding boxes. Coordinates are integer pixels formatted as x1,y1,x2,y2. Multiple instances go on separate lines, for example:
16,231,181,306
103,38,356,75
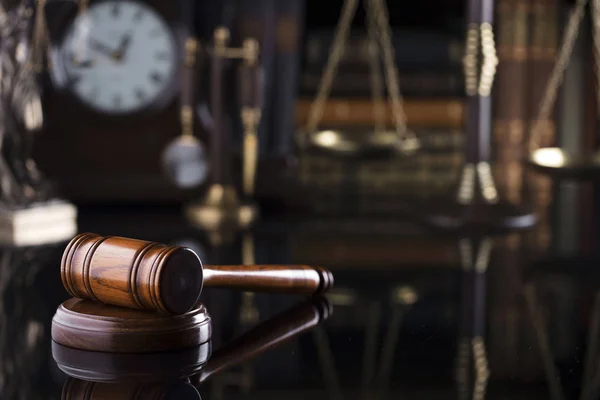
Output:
185,27,263,241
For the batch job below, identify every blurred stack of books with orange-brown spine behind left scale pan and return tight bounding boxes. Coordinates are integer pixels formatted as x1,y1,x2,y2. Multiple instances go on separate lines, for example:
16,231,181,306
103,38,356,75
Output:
296,28,465,213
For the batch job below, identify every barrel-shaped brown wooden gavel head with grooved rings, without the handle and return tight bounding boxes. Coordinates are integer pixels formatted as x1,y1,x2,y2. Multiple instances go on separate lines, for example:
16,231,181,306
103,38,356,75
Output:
61,233,203,314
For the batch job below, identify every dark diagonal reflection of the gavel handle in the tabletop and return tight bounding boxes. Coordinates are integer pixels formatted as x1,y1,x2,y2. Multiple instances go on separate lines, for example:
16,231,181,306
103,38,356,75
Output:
191,297,332,385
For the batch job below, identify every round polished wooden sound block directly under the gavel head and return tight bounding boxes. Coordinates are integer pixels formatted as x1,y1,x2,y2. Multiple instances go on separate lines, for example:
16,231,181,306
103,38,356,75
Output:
52,298,212,353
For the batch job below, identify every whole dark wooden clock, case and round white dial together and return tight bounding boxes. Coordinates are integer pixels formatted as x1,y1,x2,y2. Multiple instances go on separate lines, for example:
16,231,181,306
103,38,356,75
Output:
35,0,203,202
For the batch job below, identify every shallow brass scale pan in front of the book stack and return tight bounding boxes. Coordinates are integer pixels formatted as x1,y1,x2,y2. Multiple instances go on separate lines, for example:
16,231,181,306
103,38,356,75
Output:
306,129,419,157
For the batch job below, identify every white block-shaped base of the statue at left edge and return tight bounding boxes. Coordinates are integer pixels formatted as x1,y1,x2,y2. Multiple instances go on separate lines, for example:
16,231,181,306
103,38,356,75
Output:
0,200,77,246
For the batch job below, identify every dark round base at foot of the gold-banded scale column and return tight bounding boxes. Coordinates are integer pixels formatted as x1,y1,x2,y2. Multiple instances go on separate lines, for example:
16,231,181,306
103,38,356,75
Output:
418,199,537,232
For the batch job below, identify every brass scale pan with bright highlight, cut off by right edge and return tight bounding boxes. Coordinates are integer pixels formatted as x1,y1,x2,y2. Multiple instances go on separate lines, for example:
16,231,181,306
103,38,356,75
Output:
527,147,600,180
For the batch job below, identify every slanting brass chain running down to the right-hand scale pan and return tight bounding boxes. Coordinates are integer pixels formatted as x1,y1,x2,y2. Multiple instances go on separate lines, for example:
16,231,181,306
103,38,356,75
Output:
529,0,596,151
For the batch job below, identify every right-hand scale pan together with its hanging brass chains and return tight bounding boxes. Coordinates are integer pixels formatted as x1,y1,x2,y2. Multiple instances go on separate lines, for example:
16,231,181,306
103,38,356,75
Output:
527,0,600,181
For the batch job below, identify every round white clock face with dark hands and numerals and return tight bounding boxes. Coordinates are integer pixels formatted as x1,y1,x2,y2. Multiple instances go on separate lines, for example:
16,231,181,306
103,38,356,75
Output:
52,0,178,114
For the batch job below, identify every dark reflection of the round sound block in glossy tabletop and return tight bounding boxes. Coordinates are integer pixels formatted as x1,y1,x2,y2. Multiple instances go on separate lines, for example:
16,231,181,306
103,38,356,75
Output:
52,341,211,383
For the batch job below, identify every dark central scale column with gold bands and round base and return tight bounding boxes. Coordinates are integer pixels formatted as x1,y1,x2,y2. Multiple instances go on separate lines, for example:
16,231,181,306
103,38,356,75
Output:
418,0,537,231
